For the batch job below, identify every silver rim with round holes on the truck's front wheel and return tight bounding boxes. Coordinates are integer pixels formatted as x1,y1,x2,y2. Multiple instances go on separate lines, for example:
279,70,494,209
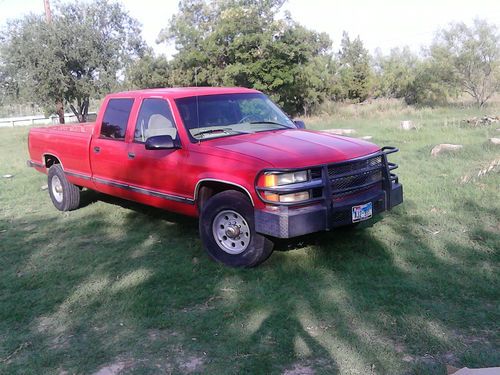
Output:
212,210,251,255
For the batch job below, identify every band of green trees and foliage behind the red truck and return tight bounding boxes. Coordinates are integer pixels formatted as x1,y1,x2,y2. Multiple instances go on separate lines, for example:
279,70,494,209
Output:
0,0,500,121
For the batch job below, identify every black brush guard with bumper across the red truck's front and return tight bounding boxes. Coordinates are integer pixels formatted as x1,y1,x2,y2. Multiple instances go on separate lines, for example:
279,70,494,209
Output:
255,147,403,238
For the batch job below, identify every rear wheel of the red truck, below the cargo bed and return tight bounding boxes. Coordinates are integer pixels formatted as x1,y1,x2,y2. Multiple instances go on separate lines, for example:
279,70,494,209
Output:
47,164,80,211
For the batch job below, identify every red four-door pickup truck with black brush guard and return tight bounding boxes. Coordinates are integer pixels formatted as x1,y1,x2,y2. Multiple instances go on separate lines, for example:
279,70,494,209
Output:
28,87,403,267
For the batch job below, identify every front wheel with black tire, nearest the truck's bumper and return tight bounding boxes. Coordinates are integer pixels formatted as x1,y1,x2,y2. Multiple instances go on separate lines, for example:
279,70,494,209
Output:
200,190,273,267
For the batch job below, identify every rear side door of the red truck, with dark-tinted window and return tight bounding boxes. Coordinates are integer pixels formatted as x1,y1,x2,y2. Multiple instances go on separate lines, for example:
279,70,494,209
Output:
90,98,134,192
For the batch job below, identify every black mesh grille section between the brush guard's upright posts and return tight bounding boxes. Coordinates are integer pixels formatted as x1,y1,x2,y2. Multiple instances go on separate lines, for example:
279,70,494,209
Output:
328,156,383,200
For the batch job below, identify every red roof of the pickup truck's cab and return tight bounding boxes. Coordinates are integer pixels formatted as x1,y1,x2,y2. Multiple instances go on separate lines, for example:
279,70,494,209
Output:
108,87,260,99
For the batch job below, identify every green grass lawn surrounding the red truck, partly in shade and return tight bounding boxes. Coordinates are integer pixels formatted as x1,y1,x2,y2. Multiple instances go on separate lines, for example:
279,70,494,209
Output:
0,102,500,374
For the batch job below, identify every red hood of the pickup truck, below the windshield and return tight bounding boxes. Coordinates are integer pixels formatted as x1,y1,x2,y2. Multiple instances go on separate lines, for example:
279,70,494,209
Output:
207,129,380,168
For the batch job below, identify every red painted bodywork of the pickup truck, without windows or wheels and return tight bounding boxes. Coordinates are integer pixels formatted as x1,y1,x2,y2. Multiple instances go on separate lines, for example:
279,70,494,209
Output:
29,87,380,216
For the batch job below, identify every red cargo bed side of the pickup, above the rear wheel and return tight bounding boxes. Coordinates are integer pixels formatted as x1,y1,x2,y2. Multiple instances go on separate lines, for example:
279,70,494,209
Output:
28,123,94,177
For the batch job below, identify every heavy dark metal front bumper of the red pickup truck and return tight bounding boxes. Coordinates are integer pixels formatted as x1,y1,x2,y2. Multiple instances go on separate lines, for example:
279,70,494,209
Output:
255,148,403,238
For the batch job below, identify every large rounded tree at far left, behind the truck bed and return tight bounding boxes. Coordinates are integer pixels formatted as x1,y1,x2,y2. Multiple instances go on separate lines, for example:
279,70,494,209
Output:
0,0,145,123
